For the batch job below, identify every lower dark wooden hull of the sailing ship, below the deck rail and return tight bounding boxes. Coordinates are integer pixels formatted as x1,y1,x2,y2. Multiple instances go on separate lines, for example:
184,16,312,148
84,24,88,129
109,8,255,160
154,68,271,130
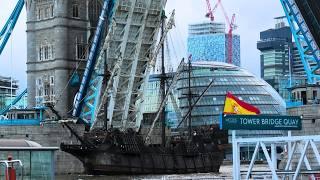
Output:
61,145,223,175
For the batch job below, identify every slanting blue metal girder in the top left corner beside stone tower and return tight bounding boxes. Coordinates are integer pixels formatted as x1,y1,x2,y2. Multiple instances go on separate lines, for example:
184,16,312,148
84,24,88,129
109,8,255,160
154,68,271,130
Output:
0,0,24,54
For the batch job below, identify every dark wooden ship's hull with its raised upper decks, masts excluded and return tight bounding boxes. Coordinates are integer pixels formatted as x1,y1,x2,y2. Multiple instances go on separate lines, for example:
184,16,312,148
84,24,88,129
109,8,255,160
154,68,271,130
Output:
61,127,227,175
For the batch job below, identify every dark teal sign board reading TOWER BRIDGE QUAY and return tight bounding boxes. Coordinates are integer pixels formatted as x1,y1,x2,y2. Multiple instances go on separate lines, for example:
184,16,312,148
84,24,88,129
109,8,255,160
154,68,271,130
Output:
220,114,302,130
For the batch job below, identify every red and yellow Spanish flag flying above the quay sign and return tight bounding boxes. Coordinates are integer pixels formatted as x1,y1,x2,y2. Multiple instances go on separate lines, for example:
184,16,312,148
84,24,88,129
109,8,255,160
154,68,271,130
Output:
223,92,260,115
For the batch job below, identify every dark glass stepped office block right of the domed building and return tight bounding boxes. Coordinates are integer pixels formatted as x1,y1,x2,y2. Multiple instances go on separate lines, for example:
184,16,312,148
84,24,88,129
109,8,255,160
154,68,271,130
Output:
257,17,316,106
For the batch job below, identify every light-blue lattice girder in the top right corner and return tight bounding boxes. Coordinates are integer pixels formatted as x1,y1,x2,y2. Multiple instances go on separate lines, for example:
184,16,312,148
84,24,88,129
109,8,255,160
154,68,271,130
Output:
280,0,320,84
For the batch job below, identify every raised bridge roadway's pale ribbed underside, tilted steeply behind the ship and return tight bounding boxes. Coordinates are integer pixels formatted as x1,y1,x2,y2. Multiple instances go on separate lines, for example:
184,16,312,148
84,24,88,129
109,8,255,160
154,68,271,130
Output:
74,0,170,130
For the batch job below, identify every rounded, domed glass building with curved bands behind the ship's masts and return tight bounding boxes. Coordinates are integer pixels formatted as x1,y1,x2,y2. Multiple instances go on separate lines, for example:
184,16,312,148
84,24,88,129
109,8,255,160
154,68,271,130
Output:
143,61,286,160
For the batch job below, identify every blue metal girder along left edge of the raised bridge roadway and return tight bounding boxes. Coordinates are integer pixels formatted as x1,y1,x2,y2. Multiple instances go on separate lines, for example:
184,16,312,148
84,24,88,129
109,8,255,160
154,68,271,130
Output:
73,0,115,126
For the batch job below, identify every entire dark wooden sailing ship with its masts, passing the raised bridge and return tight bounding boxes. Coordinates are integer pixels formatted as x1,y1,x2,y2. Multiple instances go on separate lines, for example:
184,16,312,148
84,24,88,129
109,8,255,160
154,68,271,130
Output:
60,55,228,175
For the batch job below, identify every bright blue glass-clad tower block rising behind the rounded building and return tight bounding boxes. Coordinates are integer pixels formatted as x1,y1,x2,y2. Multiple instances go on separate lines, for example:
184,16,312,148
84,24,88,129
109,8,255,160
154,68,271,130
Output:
187,22,241,66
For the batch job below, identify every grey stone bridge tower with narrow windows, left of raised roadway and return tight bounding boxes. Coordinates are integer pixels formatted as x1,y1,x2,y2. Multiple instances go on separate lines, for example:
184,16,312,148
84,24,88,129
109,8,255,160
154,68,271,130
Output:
26,0,100,116
